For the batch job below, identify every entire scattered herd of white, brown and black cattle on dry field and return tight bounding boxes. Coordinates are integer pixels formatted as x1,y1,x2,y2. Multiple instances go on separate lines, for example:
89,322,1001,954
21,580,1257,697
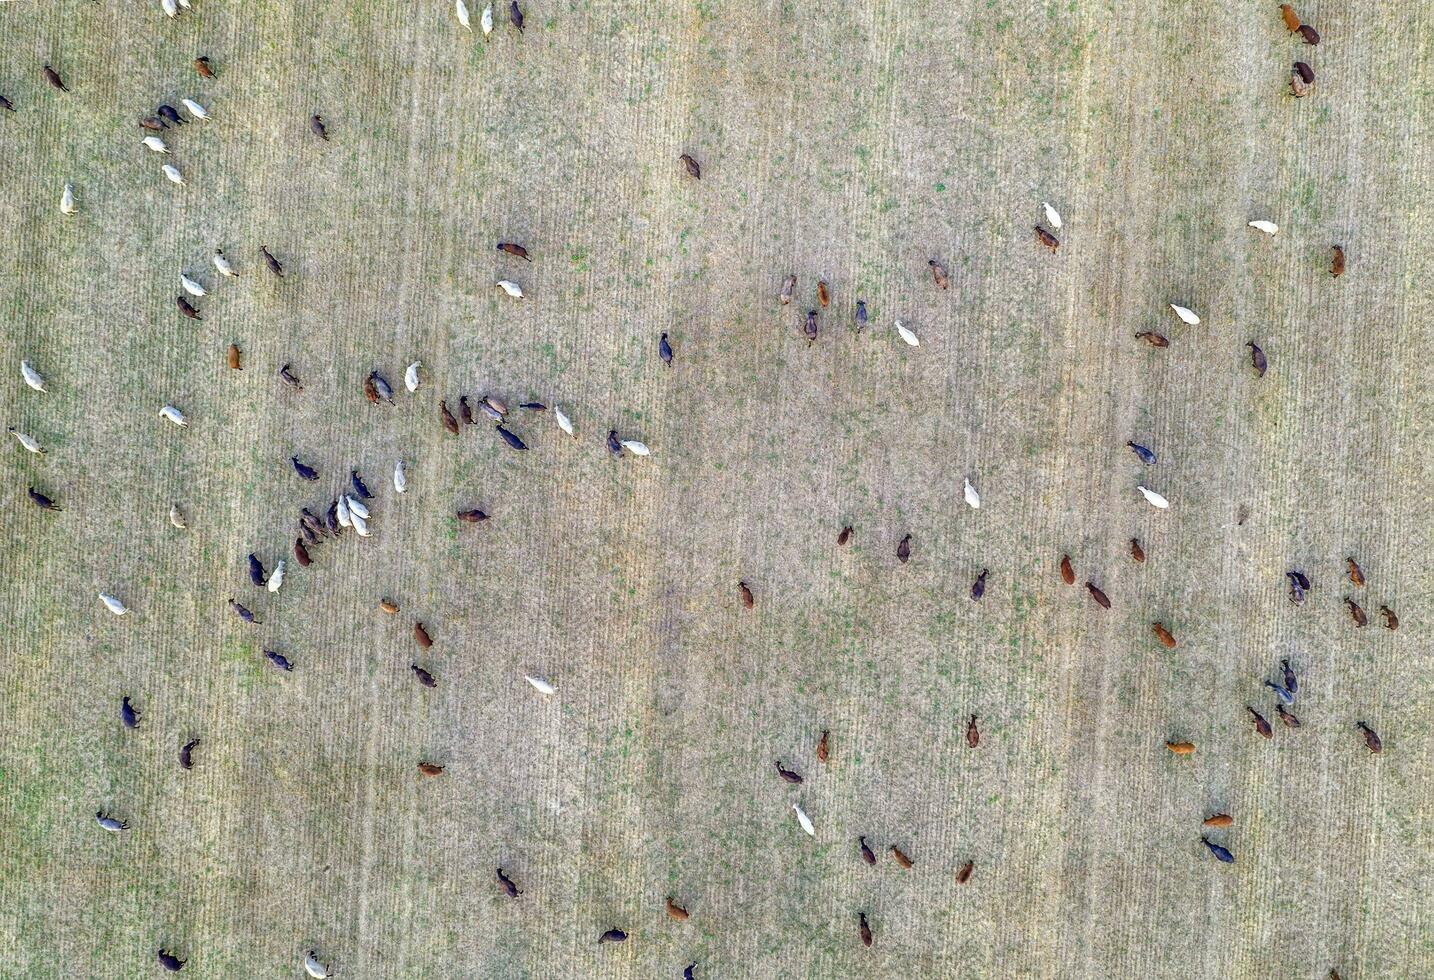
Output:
0,0,1400,980
